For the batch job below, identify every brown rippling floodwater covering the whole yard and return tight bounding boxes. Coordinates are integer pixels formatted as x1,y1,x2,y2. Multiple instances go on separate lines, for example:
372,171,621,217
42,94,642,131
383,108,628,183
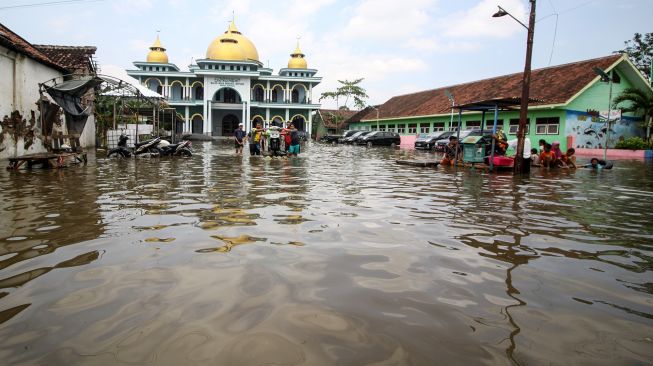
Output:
0,142,653,365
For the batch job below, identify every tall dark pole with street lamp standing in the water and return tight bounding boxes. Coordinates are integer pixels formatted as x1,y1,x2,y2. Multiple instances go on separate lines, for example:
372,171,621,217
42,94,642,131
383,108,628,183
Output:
492,0,535,174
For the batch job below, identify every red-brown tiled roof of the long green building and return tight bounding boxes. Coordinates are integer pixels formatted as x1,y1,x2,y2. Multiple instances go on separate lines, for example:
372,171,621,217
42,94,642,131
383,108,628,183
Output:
361,55,622,121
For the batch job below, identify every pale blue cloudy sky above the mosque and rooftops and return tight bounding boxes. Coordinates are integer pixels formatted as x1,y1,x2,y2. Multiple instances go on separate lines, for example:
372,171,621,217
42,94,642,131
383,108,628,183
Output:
0,0,653,108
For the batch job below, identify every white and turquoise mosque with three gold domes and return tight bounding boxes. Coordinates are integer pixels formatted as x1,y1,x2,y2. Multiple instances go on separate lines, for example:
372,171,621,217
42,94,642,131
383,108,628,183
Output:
127,21,322,136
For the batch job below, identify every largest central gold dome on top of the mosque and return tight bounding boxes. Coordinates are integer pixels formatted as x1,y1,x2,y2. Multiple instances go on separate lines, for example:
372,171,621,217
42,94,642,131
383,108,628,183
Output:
206,20,258,61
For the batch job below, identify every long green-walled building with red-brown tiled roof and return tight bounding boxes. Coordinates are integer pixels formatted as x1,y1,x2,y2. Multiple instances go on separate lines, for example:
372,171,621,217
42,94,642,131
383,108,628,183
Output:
350,55,653,148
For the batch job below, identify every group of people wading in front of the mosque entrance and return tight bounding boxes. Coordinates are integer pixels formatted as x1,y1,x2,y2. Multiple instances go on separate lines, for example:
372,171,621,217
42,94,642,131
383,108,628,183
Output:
234,122,301,156
